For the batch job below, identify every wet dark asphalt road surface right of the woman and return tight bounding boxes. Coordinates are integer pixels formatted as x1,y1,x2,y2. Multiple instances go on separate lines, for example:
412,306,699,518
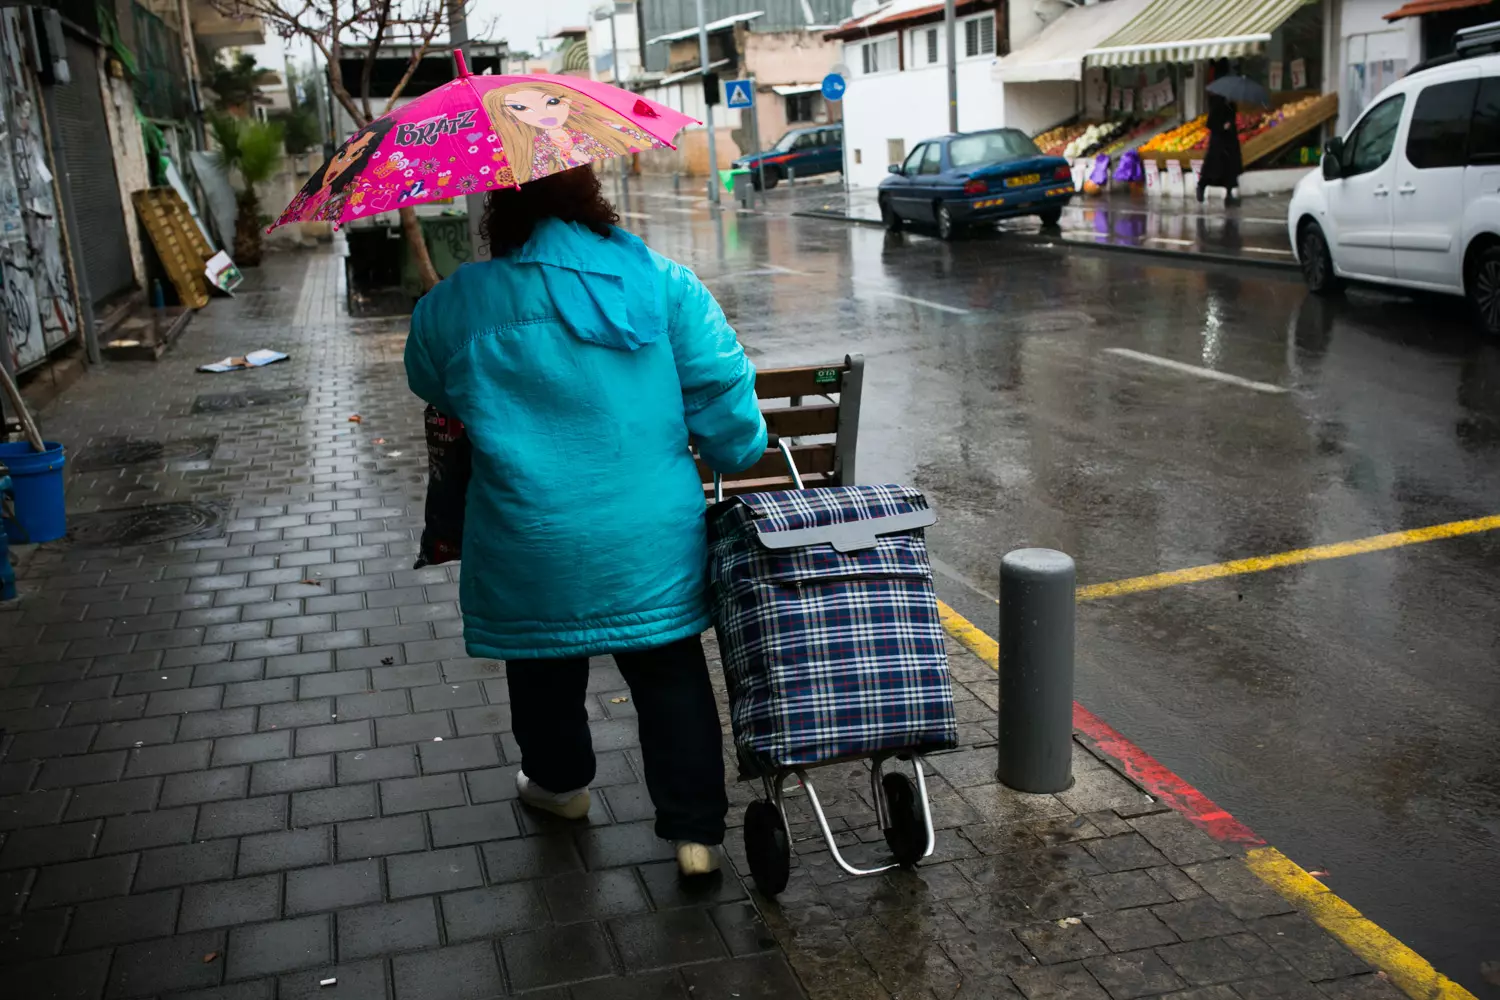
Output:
627,195,1500,1000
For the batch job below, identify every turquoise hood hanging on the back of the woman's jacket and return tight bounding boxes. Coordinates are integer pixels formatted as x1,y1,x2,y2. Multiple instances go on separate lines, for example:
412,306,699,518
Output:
516,219,666,351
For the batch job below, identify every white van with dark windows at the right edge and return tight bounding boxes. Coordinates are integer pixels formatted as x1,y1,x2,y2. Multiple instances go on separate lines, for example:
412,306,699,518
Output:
1287,22,1500,336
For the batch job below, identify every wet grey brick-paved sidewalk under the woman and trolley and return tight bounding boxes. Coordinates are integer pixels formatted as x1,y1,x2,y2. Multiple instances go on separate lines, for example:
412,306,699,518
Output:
0,244,1400,1000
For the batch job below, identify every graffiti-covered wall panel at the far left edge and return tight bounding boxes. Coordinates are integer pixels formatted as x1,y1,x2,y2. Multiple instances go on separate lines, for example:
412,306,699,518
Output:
0,7,78,369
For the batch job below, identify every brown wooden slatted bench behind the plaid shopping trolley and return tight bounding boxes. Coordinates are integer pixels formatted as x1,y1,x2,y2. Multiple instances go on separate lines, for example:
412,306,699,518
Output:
698,354,864,501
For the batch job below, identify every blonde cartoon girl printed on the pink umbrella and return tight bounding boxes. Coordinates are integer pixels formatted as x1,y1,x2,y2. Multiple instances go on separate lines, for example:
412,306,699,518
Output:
485,81,663,184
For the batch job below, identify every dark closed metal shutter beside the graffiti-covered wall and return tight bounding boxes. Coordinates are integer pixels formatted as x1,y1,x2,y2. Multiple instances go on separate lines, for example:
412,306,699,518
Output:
53,34,135,304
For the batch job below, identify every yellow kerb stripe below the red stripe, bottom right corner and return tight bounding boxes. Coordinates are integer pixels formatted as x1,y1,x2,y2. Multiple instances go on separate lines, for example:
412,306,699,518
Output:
1245,847,1476,1000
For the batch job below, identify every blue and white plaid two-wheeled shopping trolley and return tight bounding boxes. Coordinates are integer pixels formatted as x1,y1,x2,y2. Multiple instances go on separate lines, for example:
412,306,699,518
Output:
708,441,959,895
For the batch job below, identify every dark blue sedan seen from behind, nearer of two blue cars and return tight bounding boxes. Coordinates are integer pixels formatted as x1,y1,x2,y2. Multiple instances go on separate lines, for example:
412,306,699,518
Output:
879,129,1074,240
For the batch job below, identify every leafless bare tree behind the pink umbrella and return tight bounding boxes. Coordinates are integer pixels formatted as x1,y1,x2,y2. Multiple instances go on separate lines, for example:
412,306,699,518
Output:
213,0,473,289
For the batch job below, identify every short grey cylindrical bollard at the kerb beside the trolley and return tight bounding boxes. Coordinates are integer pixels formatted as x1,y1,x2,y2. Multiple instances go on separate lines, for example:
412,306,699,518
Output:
999,549,1074,792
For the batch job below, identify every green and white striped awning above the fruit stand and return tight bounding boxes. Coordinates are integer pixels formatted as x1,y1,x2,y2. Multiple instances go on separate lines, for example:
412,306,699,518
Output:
1085,0,1317,66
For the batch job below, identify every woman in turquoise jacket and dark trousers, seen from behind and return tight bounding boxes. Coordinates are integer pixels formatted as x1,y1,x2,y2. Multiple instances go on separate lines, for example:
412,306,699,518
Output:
407,166,767,874
